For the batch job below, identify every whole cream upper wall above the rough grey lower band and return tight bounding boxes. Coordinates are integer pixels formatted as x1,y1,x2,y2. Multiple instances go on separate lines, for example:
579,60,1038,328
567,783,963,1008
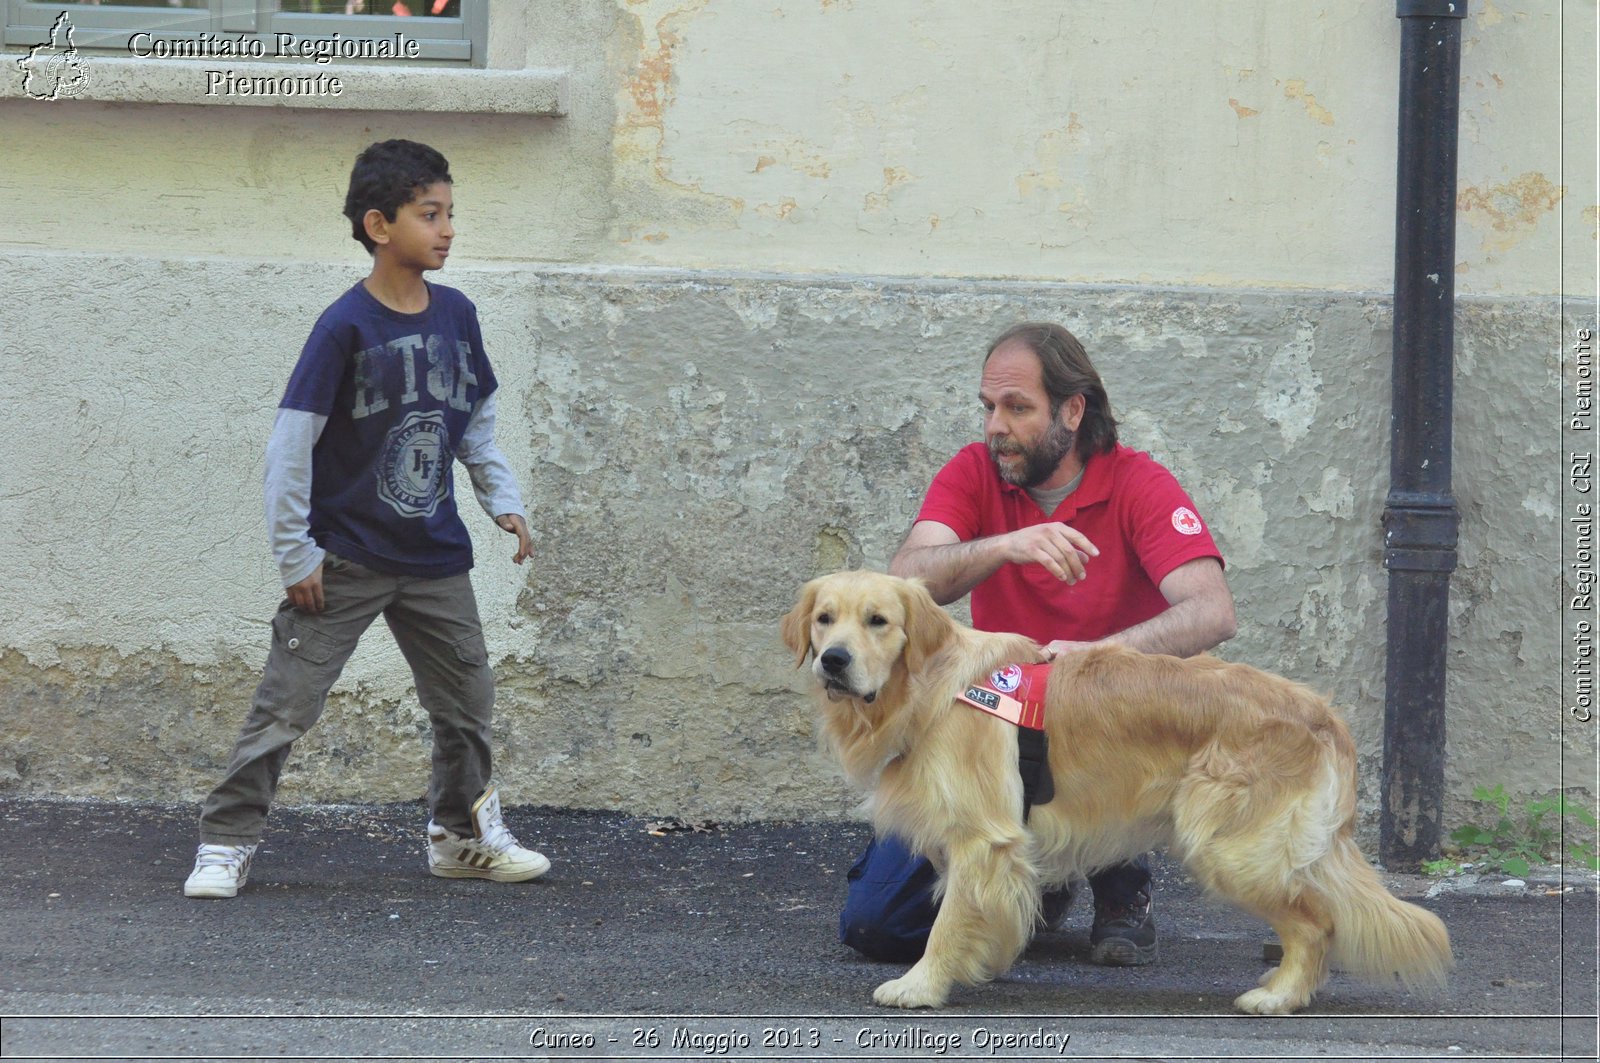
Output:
0,0,1597,295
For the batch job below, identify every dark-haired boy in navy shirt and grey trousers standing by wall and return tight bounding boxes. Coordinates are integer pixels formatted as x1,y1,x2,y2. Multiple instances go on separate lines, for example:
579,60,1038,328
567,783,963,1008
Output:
184,141,550,897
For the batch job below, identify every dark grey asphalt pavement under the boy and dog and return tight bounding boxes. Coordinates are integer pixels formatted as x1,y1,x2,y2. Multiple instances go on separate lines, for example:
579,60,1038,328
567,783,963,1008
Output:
0,799,1597,1060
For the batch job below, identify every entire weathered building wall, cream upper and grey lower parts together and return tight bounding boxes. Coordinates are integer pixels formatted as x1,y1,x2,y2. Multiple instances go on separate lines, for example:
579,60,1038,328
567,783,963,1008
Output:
0,0,1600,818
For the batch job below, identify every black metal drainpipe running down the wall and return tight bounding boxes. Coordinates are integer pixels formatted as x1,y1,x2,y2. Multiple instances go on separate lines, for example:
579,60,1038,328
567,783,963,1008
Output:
1379,0,1467,871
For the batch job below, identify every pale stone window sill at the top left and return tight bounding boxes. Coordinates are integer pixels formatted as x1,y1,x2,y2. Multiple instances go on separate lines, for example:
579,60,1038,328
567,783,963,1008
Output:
0,51,566,117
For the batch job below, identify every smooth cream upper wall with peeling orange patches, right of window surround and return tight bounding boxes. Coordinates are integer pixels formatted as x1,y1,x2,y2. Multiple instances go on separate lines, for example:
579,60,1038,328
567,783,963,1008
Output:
616,0,1595,293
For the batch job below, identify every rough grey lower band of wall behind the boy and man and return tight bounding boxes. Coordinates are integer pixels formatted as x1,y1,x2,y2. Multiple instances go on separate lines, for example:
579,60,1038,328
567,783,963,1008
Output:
0,255,1592,816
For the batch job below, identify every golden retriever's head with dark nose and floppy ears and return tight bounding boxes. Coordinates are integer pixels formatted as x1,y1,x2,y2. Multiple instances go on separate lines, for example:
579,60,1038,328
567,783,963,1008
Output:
782,572,955,704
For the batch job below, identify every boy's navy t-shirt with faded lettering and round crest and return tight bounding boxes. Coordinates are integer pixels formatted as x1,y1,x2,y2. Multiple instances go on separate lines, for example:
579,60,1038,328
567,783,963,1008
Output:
278,283,496,576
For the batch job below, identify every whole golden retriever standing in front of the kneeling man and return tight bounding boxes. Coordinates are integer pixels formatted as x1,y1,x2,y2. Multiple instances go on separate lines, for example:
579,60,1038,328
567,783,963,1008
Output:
782,572,1451,1015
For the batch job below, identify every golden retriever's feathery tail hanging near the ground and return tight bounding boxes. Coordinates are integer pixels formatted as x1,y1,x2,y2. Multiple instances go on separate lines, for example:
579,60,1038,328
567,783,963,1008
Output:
1306,832,1454,989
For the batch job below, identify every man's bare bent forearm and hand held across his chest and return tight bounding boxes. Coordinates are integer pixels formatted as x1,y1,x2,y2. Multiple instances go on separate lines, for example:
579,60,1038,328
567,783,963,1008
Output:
890,520,1100,605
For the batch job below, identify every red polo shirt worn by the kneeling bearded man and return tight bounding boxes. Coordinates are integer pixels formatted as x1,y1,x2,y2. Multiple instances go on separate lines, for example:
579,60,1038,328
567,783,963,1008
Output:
917,443,1222,642
